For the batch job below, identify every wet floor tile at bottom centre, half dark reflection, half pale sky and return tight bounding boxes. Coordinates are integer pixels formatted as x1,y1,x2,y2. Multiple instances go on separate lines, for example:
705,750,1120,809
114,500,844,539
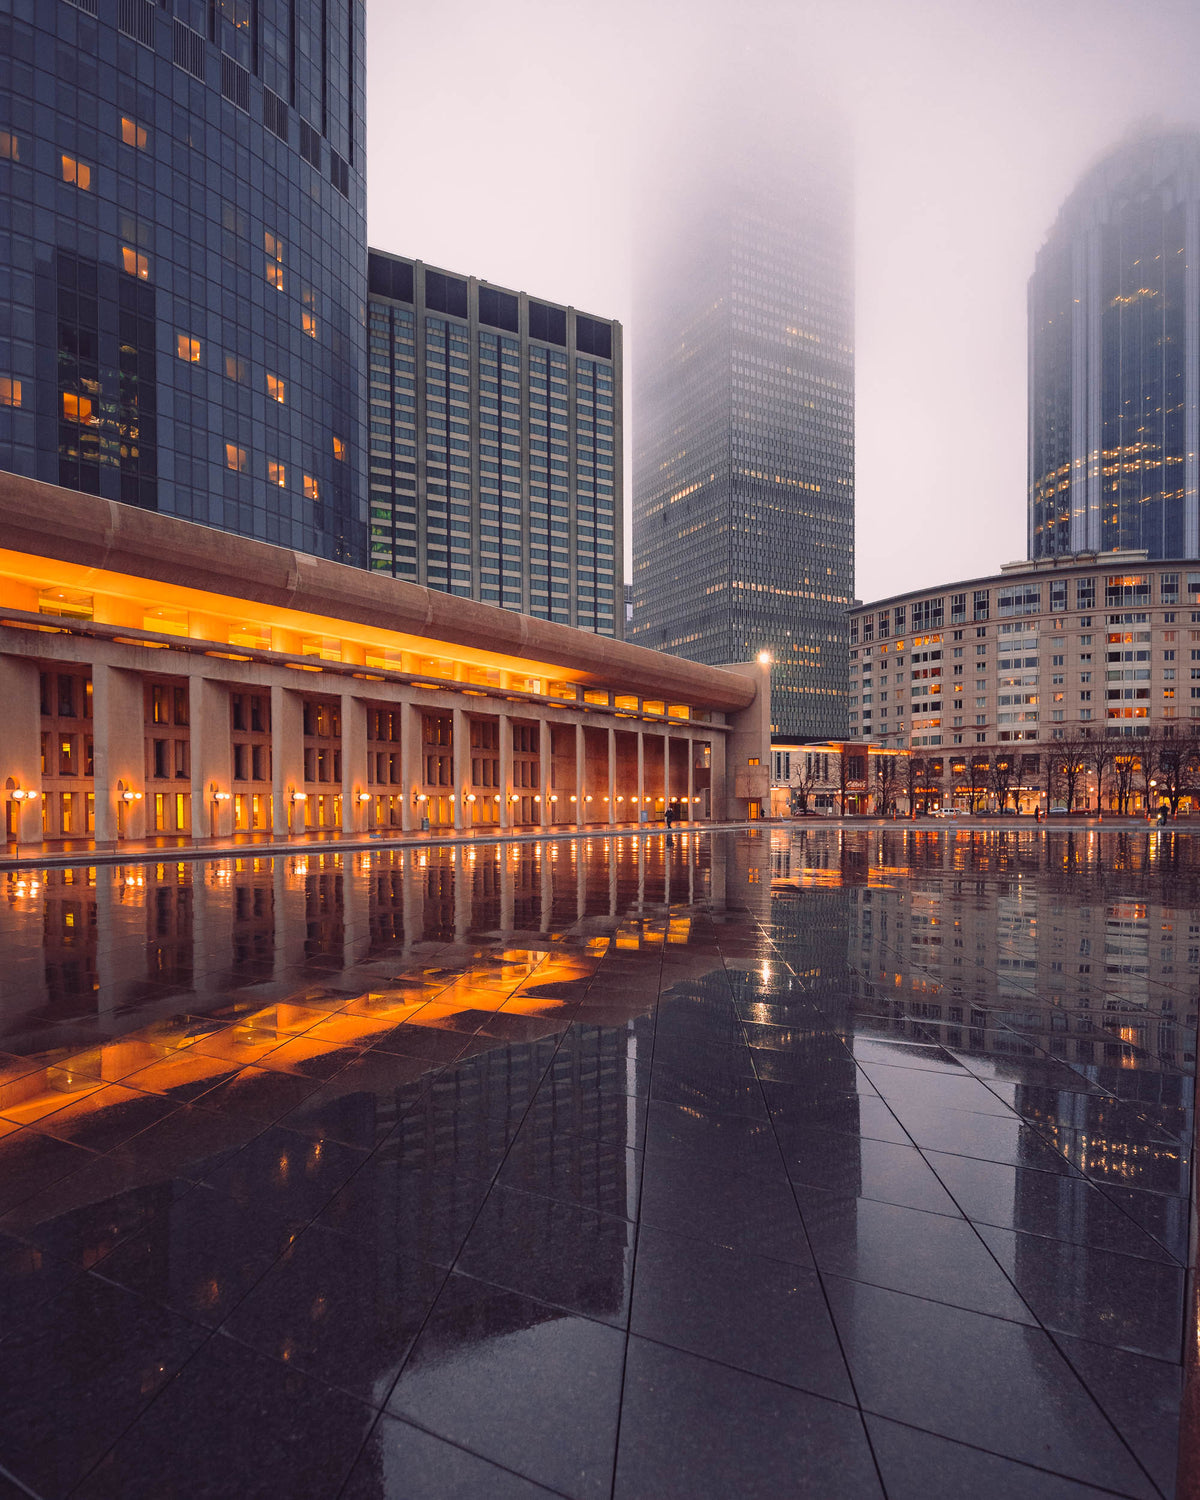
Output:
389,1275,624,1500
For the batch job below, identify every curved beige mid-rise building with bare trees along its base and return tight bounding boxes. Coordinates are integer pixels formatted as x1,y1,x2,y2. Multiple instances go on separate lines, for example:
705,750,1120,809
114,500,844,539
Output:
849,552,1200,812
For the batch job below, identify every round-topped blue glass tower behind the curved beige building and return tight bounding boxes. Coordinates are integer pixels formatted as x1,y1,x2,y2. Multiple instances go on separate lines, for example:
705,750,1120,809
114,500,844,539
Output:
1029,131,1200,558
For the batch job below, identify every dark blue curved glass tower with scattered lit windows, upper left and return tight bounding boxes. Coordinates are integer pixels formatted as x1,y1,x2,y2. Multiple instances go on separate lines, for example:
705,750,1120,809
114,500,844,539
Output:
0,0,366,564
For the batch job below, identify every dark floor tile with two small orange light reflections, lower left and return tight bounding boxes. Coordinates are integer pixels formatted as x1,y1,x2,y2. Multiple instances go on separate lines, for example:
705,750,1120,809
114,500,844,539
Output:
206,1125,366,1223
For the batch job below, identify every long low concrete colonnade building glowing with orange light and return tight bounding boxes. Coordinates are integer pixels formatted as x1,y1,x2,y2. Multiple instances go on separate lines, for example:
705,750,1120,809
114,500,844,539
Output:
0,474,770,846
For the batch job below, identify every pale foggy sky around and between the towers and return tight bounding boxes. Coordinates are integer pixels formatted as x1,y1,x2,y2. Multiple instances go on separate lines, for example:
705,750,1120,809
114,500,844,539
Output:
368,0,1200,599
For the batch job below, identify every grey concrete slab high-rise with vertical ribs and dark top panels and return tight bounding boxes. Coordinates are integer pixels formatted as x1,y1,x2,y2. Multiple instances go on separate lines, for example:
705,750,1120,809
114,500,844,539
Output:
369,251,624,638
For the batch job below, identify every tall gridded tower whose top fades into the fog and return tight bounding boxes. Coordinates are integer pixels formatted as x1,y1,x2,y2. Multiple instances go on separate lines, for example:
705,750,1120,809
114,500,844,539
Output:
633,96,854,737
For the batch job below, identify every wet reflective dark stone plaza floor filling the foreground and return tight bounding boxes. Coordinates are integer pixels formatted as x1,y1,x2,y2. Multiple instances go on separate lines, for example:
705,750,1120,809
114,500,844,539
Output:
0,827,1200,1500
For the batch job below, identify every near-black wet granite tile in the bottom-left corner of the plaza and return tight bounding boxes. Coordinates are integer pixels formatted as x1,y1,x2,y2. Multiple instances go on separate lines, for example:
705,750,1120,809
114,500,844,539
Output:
0,1275,207,1497
